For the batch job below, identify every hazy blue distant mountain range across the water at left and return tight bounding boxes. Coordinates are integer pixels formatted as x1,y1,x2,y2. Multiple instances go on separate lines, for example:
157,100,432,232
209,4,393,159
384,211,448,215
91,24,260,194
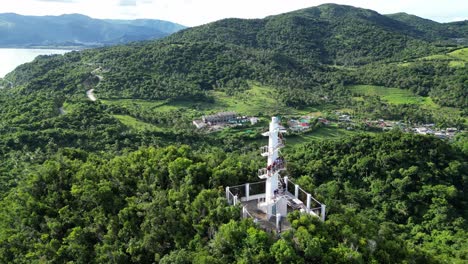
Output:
0,13,185,47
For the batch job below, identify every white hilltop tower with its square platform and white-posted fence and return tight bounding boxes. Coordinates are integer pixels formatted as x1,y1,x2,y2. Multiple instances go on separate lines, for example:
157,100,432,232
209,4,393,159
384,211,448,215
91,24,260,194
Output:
226,117,325,232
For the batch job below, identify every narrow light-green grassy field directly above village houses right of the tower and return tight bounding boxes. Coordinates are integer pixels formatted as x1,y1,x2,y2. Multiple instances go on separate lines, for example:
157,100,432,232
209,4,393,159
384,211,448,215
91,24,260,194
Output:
349,85,428,105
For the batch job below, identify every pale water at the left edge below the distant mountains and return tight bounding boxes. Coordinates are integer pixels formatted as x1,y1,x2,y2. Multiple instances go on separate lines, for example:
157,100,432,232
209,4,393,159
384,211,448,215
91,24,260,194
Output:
0,48,71,78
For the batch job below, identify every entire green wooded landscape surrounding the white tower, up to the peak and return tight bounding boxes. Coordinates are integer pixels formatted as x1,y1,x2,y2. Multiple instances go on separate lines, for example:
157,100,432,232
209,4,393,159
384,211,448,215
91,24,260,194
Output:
0,5,468,264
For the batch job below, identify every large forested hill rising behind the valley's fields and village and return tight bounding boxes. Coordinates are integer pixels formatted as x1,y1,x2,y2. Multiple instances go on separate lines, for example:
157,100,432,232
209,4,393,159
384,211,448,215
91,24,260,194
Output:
6,4,467,107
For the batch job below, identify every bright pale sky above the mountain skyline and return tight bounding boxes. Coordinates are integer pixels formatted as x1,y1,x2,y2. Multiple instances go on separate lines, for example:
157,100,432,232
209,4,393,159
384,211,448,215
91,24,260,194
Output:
0,0,468,26
